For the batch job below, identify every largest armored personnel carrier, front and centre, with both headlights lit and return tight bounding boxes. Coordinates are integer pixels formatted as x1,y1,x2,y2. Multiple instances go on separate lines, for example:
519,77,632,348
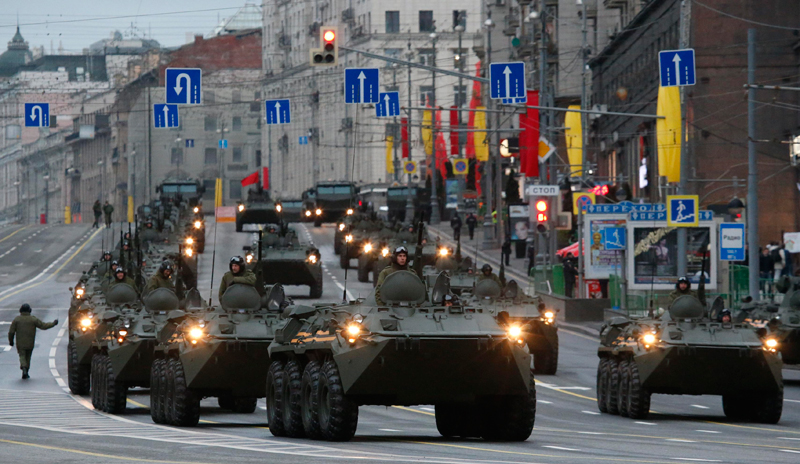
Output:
267,271,536,441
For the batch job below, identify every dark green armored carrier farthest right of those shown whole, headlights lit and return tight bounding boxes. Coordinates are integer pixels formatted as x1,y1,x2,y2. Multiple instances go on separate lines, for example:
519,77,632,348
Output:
597,295,783,424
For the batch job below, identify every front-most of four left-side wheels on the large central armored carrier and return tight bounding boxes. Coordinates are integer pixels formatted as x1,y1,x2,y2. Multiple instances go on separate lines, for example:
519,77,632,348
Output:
314,361,358,441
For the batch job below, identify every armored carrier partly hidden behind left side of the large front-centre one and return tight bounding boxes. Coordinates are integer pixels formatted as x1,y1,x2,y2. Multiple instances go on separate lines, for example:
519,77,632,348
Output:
150,284,286,427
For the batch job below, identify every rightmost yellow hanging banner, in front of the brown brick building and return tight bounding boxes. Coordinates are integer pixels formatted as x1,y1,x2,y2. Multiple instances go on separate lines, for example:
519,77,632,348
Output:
656,87,681,182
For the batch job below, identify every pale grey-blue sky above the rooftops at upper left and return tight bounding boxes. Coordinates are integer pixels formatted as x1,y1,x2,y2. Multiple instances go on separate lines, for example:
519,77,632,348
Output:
0,0,255,54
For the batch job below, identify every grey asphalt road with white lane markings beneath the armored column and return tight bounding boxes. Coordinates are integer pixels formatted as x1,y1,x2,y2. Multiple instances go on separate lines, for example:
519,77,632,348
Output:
0,223,800,464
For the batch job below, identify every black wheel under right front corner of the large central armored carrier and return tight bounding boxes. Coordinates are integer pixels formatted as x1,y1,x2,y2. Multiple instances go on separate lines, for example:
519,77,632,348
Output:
481,372,536,441
